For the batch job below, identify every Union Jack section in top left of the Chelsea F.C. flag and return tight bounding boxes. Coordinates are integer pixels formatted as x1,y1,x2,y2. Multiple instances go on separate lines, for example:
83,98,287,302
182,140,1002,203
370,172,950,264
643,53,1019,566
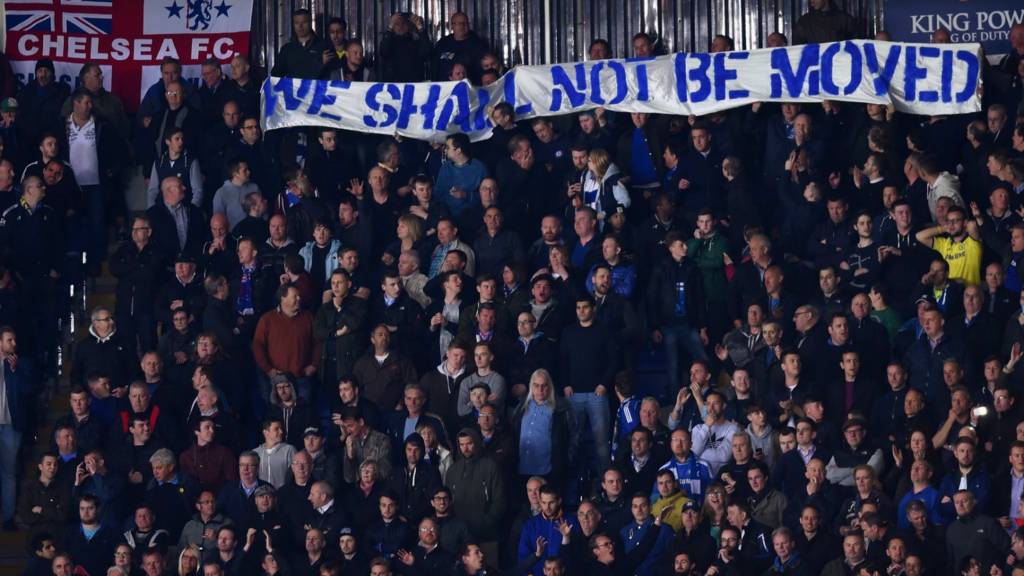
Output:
6,0,114,35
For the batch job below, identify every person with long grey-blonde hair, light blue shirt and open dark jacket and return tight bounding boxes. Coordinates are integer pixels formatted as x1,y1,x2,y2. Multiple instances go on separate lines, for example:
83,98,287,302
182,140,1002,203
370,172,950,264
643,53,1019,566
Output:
512,368,577,489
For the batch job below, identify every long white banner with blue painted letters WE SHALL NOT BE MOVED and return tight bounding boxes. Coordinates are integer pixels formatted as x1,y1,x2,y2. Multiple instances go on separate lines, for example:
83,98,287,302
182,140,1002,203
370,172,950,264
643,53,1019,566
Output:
262,40,981,140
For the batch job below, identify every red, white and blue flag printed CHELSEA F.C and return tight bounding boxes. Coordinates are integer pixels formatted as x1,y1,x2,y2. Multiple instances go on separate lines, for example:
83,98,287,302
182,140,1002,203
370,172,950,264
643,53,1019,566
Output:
4,0,253,111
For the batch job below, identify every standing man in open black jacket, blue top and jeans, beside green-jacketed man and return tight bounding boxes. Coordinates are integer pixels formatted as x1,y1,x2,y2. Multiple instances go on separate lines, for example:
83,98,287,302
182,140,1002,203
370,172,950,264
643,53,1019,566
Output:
647,231,708,394
